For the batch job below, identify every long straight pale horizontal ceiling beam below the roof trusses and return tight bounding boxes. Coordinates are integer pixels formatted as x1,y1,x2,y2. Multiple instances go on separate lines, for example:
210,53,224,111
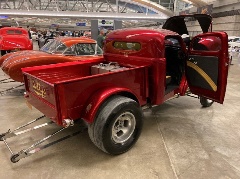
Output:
0,9,168,21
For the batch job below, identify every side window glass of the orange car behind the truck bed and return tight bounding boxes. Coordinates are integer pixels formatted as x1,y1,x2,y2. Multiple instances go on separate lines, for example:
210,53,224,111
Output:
64,43,103,55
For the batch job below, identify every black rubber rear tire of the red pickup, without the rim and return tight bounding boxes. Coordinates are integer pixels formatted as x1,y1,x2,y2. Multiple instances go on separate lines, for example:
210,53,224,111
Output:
88,95,143,155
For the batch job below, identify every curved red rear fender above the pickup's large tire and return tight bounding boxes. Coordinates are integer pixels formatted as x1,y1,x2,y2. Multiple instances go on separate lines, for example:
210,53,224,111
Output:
83,88,138,123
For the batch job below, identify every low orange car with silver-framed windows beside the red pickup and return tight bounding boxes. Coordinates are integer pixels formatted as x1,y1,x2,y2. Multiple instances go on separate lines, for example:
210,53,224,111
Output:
0,37,102,82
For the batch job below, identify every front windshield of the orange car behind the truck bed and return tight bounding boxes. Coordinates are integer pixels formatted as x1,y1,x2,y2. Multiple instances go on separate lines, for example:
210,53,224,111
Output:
40,40,67,54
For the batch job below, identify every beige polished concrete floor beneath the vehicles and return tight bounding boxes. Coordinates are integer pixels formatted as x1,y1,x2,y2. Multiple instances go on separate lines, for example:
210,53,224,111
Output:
0,44,240,179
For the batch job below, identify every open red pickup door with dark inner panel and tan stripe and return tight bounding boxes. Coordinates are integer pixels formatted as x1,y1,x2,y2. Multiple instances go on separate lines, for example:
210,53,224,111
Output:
186,32,229,103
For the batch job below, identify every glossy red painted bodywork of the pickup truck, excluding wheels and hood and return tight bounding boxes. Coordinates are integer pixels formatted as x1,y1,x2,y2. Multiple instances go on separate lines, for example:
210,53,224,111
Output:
23,15,229,125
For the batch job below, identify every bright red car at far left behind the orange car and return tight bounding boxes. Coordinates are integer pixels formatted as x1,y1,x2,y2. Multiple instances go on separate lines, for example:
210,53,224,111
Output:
0,27,33,56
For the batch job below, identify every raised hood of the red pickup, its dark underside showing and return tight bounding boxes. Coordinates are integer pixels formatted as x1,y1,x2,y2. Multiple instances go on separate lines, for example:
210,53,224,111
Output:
162,14,212,35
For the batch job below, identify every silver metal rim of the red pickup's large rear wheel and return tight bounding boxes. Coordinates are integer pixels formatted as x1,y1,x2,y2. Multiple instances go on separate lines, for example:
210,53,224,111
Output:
112,112,136,143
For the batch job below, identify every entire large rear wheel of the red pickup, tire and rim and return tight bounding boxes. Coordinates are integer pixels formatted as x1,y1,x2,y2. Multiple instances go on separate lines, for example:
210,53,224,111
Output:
88,96,143,155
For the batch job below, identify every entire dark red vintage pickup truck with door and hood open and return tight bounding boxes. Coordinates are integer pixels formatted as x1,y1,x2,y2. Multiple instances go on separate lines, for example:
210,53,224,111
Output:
2,14,229,160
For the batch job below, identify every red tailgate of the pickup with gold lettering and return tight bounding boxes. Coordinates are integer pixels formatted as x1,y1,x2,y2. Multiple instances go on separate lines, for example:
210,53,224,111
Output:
24,72,61,125
